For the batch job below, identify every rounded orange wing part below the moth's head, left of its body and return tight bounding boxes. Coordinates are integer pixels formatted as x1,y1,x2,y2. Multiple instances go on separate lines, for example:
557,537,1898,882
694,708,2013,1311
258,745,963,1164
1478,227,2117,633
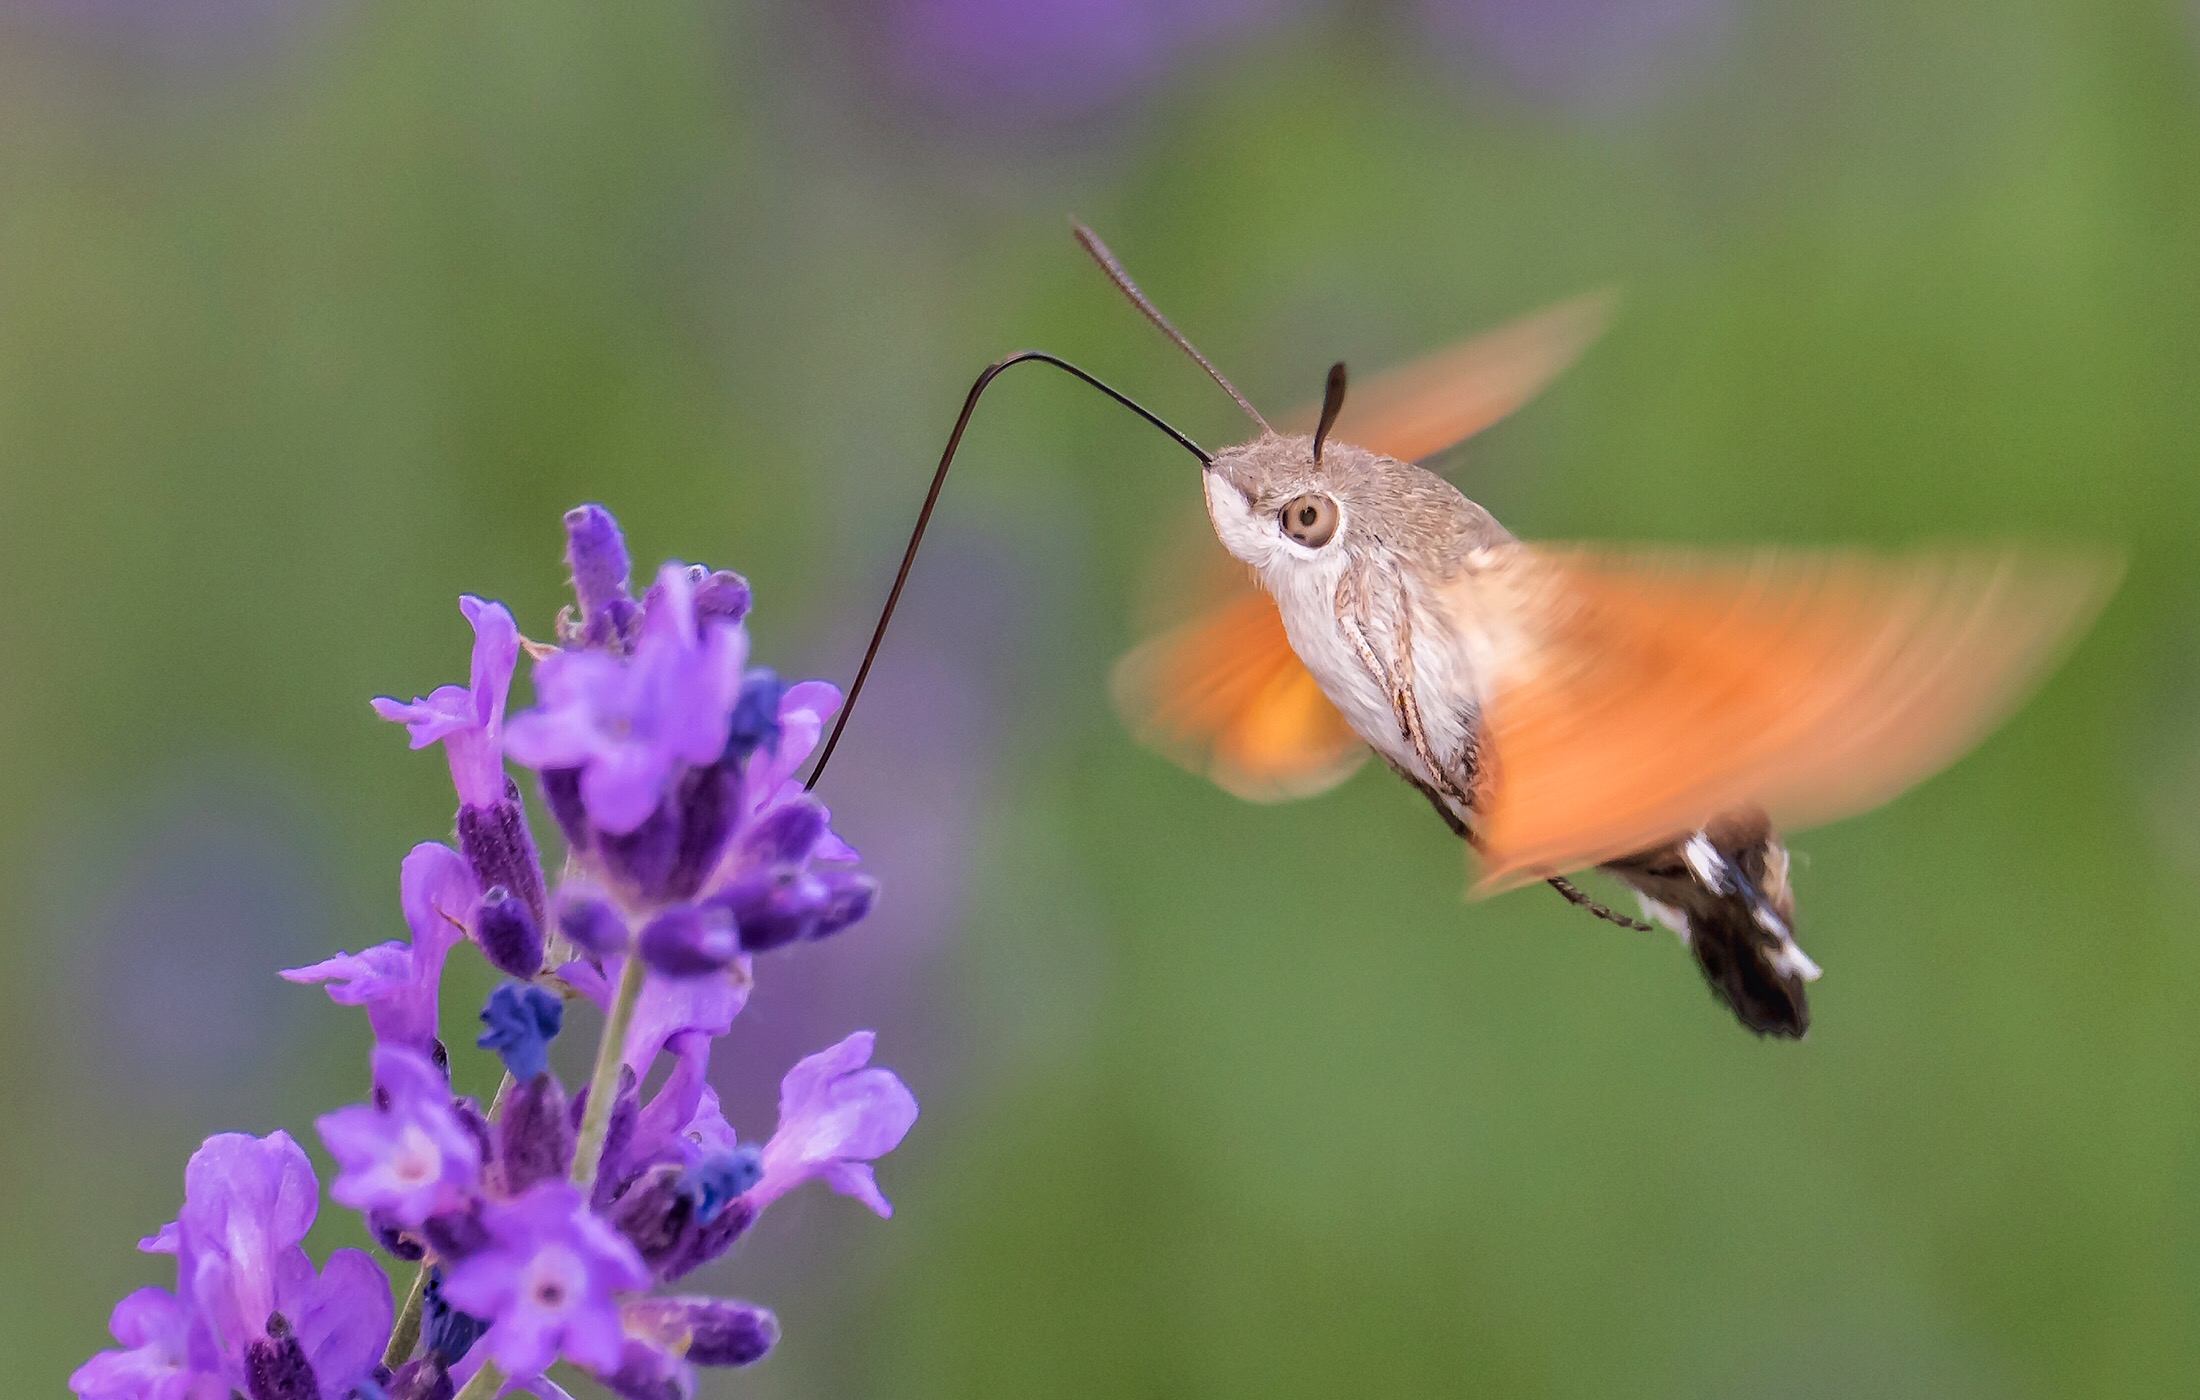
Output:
1113,588,1368,801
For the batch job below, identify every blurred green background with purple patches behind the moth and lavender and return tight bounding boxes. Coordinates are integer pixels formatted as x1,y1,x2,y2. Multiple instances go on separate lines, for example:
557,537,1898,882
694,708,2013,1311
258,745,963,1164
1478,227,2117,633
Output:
0,0,2200,1398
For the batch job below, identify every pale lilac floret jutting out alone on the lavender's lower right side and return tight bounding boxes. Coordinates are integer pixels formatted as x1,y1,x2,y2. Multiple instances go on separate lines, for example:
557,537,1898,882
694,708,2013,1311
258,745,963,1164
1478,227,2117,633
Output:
748,1030,917,1215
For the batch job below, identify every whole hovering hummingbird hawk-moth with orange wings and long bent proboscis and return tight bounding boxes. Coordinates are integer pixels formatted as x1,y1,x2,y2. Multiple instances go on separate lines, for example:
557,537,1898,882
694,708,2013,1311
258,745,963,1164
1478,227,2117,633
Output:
810,227,2116,1037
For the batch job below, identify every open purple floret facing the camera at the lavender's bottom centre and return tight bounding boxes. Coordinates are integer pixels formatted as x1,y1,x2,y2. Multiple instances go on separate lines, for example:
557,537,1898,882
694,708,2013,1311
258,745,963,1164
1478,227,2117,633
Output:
442,1182,649,1376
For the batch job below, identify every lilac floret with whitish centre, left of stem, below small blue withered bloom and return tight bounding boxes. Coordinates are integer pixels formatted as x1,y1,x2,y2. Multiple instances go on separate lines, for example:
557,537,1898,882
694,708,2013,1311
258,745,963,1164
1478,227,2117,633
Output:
315,1046,482,1228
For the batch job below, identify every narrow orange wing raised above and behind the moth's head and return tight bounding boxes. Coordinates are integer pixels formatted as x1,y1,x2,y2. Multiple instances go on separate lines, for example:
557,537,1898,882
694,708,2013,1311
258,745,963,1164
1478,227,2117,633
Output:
1280,291,1615,462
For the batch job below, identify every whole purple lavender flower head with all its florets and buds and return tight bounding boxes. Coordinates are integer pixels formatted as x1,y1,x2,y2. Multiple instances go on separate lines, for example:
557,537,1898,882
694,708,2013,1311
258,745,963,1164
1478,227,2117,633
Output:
70,506,917,1400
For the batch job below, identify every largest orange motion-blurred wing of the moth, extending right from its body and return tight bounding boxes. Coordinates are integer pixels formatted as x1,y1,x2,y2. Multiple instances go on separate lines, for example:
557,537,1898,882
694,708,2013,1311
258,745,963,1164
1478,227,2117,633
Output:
1450,546,2119,894
